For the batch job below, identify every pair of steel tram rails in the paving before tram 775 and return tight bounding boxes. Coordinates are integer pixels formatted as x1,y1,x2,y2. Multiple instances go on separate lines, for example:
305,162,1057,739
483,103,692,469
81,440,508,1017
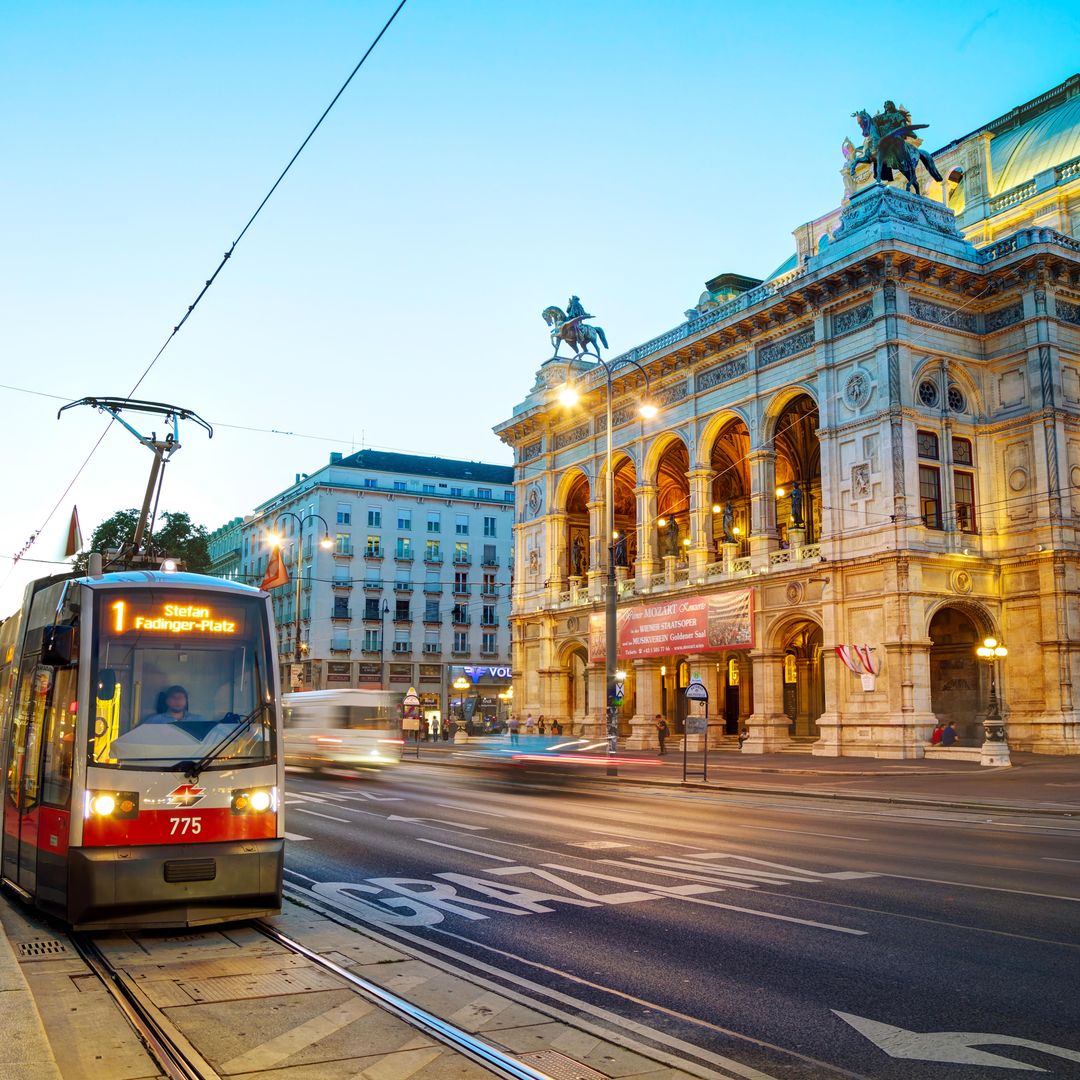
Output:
69,919,551,1080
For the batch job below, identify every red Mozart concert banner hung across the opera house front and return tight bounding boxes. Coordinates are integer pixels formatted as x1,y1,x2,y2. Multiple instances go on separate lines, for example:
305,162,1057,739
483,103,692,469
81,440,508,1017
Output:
589,589,754,662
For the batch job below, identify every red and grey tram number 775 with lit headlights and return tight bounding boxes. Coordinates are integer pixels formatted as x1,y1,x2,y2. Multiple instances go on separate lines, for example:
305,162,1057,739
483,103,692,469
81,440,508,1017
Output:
0,566,285,930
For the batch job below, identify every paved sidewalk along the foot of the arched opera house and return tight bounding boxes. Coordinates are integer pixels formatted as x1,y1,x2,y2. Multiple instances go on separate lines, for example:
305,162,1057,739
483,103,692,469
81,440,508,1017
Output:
402,737,1080,816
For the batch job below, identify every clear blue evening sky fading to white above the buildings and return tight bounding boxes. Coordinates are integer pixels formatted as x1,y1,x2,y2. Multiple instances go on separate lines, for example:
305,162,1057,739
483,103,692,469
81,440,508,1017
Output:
0,0,1080,611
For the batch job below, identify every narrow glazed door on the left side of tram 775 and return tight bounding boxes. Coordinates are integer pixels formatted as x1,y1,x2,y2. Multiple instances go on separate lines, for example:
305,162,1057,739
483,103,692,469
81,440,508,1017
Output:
3,665,56,893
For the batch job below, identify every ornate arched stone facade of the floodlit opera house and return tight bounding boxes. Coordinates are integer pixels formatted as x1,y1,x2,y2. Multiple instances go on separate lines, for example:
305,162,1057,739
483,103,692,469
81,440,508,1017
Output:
496,81,1080,758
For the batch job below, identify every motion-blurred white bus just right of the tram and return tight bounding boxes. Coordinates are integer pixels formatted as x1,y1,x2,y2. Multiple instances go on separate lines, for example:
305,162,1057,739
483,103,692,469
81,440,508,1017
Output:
282,690,402,771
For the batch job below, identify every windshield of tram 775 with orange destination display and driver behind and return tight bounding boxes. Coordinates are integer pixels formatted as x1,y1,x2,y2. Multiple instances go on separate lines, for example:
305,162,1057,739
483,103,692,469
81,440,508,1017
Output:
89,589,274,769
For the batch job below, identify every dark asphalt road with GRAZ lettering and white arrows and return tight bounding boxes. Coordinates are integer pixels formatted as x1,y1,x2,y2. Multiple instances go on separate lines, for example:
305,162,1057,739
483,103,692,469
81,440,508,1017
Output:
278,764,1080,1080
